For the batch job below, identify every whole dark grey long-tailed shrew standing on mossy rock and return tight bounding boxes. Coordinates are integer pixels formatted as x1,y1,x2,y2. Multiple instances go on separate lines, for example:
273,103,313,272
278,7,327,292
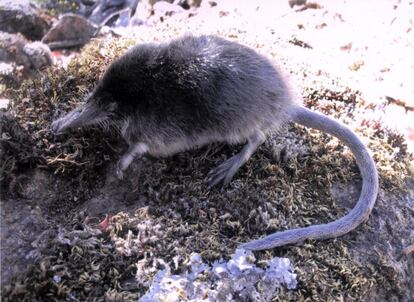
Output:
52,36,378,250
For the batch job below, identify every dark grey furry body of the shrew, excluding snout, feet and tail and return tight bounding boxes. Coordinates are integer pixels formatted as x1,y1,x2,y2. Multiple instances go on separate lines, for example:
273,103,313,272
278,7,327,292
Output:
94,36,292,155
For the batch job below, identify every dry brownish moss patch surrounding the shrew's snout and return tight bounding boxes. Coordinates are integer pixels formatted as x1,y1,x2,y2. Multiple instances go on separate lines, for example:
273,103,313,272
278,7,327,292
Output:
2,40,133,193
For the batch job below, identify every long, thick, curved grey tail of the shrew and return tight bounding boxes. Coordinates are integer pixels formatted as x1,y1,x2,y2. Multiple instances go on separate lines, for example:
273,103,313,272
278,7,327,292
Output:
241,107,378,250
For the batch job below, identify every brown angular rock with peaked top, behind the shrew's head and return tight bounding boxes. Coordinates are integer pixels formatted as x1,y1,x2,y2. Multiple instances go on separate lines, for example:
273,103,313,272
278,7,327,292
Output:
42,14,98,50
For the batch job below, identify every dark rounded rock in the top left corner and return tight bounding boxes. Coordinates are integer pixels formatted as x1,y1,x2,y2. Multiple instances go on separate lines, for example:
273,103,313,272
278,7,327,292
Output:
0,0,49,40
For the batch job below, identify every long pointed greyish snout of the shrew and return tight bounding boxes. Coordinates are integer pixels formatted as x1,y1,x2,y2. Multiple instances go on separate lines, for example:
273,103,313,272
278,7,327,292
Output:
51,103,106,134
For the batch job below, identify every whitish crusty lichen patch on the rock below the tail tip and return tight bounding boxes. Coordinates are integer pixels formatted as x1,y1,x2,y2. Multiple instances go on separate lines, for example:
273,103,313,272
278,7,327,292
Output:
137,249,297,302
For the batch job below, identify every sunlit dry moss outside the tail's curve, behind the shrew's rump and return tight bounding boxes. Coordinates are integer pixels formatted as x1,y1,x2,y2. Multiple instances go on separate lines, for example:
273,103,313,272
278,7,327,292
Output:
304,88,414,190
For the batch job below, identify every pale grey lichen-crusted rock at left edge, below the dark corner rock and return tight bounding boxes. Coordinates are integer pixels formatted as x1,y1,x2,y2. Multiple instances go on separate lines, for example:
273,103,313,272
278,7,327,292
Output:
0,32,53,74
